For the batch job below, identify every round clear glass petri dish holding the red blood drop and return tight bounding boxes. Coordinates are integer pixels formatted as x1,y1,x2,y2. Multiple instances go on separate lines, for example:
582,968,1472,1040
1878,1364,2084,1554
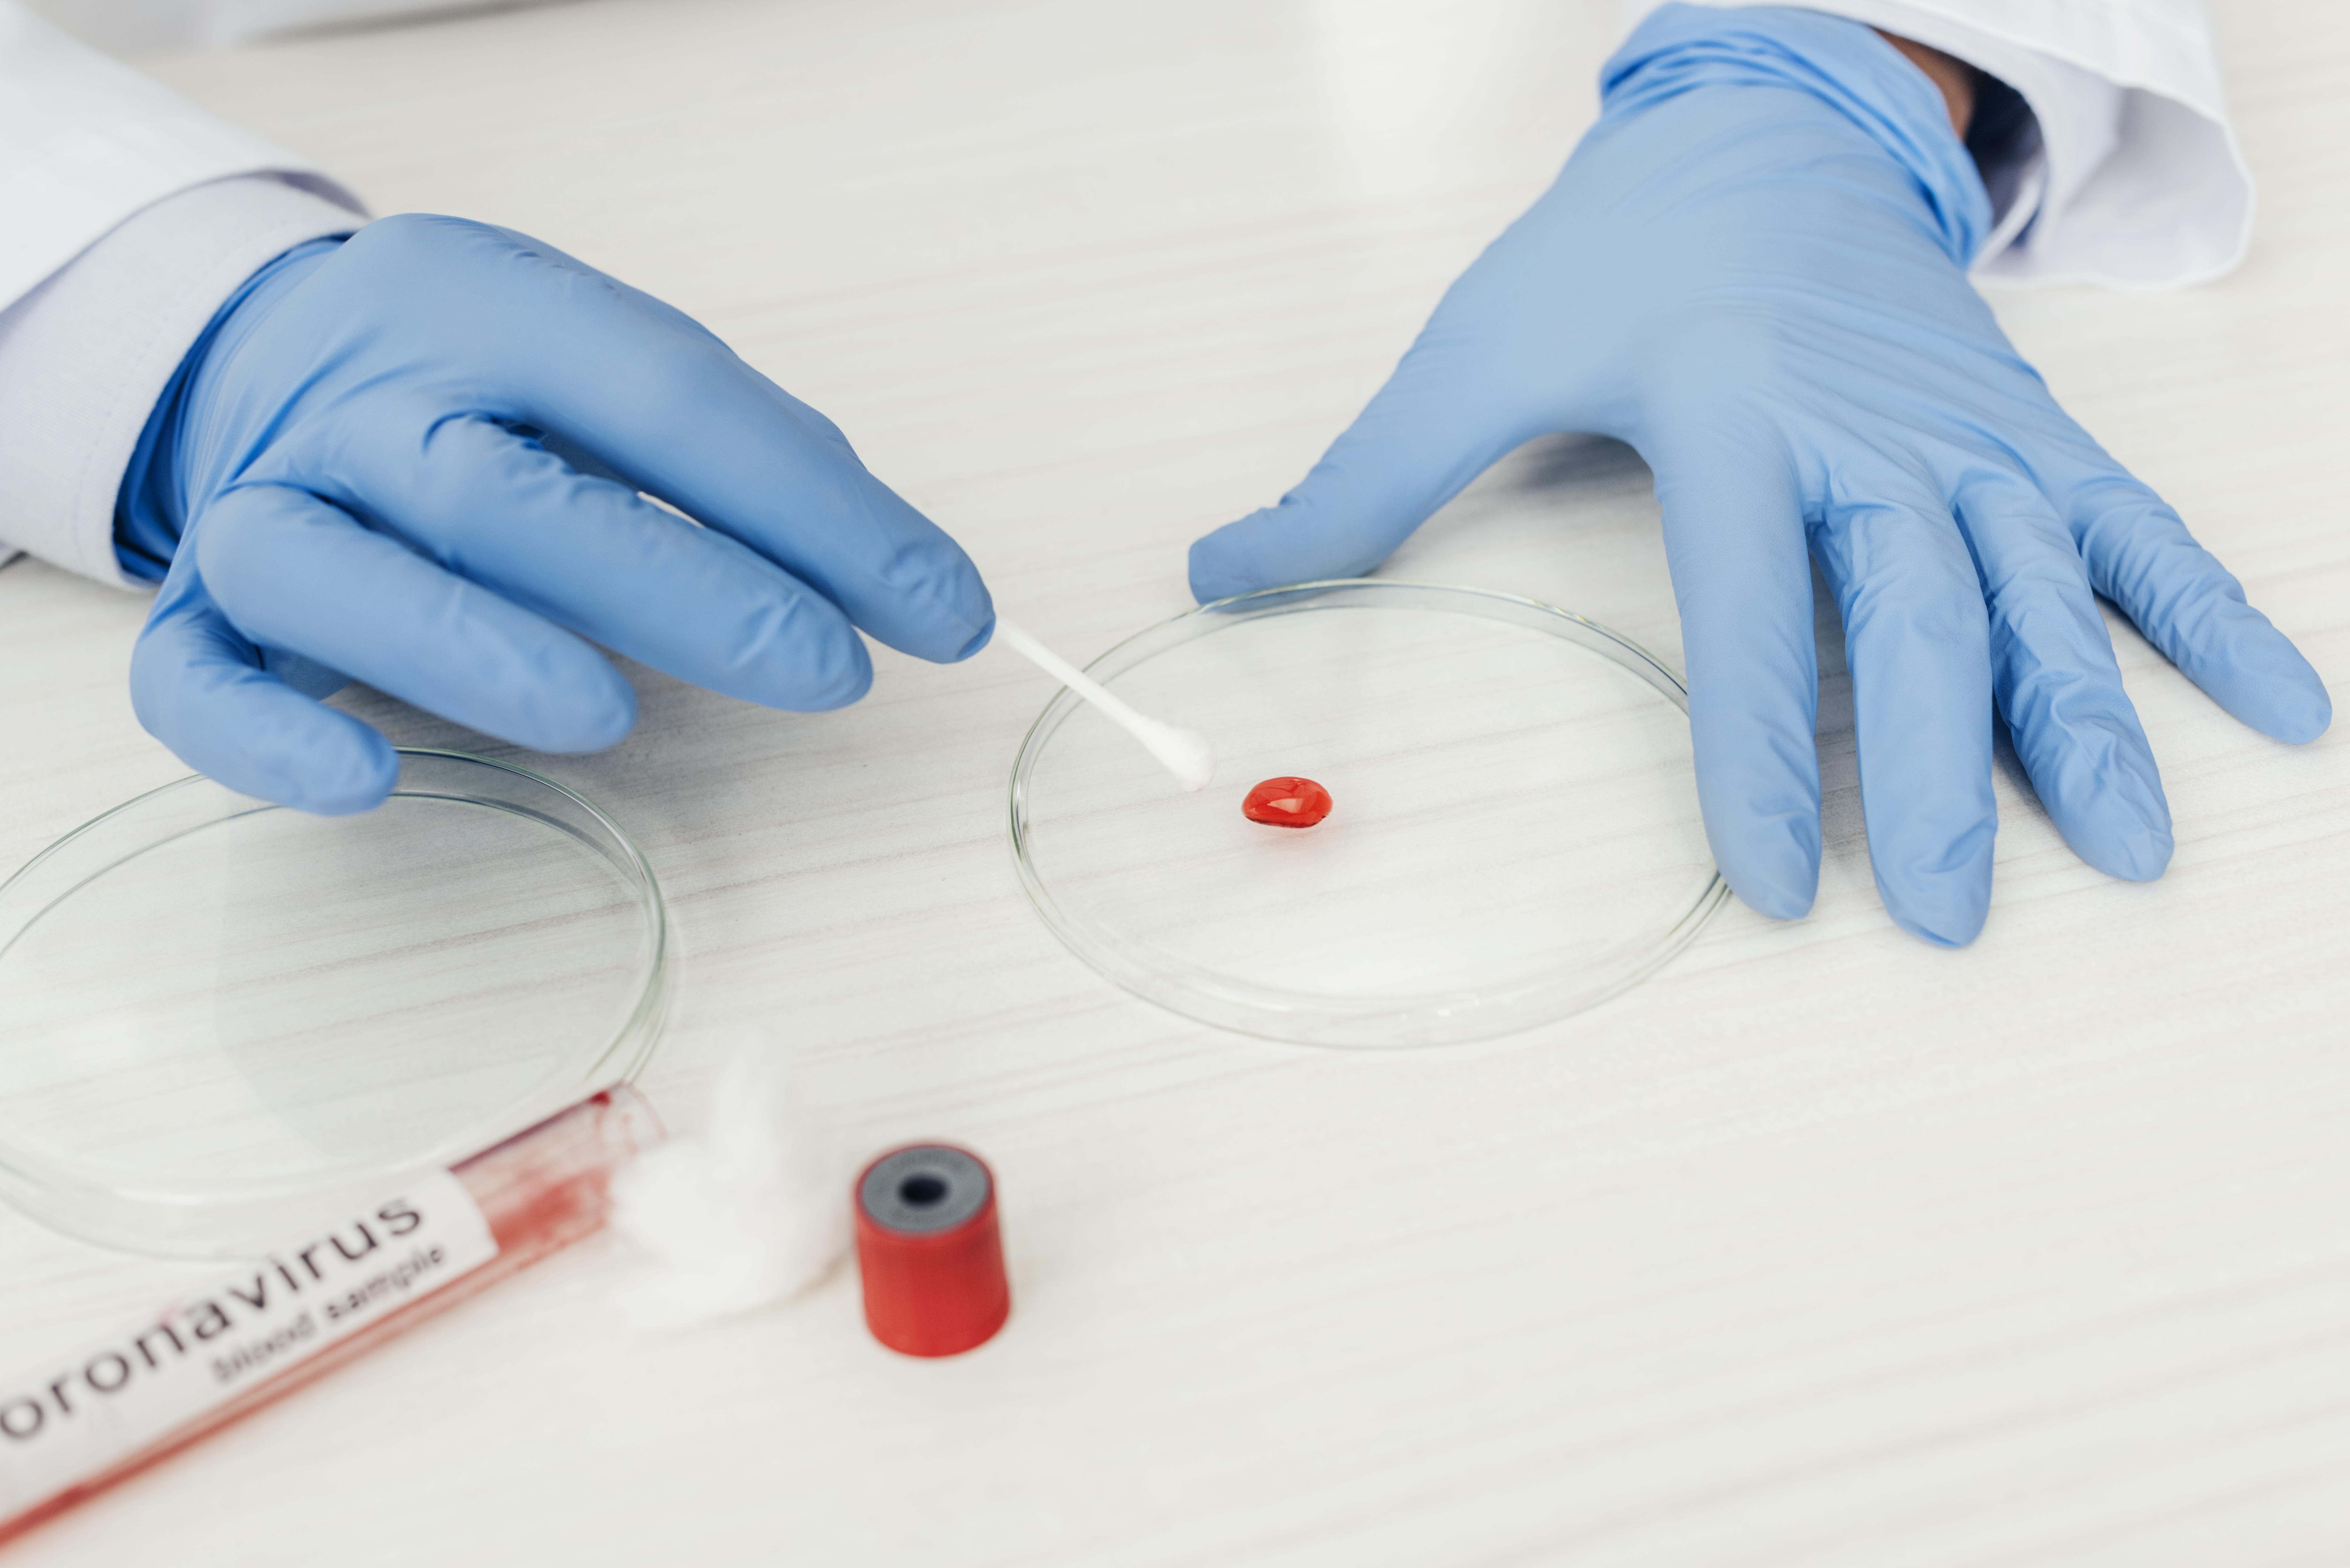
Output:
1011,581,1727,1046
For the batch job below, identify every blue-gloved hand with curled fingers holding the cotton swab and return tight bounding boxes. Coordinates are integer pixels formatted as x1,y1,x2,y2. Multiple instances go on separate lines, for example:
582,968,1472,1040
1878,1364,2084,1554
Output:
118,216,994,811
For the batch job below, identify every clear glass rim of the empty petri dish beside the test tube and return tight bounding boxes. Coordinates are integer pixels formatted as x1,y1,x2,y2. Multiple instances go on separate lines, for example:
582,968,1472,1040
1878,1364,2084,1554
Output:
0,745,672,1255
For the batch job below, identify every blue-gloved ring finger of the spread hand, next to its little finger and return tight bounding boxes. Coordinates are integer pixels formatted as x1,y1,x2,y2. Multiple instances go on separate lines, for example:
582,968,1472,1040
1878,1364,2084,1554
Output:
1958,465,2172,882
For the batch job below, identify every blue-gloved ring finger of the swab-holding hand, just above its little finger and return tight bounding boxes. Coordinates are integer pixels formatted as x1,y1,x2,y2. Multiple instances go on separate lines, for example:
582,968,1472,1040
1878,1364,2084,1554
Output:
193,484,637,752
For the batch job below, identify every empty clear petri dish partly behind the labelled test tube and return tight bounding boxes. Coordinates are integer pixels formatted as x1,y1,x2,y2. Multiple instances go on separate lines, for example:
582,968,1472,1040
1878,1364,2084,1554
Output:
0,750,667,1255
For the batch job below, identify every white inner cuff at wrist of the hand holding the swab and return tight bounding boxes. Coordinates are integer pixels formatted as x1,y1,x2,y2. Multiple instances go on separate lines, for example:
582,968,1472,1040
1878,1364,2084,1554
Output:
0,176,364,588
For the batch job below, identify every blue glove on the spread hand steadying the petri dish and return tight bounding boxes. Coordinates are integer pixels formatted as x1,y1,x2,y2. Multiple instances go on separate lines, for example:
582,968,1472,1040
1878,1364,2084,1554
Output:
1192,5,2331,945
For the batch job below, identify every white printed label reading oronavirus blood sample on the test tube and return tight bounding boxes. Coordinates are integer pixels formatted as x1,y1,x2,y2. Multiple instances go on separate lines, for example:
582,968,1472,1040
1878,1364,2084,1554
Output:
0,1171,498,1519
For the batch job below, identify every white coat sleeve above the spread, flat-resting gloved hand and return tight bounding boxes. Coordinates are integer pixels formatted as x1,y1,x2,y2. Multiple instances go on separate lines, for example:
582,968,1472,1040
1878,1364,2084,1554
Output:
1626,0,2254,289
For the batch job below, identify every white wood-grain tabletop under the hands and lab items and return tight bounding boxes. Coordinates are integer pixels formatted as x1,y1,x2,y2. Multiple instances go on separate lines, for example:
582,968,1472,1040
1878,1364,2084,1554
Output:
0,0,2350,1568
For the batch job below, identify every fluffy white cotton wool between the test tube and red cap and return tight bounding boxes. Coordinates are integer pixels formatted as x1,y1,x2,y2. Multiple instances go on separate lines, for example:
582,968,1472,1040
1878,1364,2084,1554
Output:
611,1039,848,1331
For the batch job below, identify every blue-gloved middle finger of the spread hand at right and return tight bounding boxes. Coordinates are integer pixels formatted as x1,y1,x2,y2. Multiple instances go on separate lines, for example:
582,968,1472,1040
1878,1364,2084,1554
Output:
1819,472,2000,947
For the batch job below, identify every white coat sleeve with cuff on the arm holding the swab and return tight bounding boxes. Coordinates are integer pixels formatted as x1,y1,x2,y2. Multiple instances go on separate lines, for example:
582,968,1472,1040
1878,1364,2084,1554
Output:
0,0,362,585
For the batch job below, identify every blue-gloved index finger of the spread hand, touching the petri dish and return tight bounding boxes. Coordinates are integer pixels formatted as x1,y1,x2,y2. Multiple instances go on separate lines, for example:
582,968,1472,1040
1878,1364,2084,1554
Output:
1657,440,1819,919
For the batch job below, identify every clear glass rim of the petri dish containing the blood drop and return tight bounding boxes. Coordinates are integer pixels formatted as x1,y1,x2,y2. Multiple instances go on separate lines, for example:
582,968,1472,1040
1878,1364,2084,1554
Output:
1008,578,1730,1048
